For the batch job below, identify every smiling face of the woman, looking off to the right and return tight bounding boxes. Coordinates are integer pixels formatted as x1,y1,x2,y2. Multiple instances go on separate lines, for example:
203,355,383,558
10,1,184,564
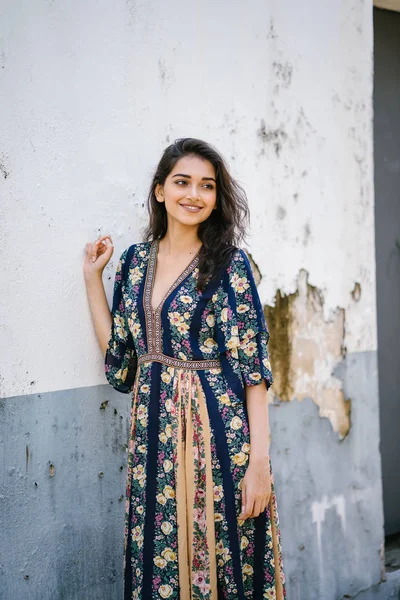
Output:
155,155,217,228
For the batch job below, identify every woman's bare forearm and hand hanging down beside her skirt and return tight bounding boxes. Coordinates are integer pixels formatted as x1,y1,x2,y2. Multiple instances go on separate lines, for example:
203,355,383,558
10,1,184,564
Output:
239,380,271,520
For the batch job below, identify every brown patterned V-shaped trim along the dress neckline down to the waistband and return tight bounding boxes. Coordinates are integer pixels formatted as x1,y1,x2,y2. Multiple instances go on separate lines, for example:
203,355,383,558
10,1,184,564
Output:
143,240,201,352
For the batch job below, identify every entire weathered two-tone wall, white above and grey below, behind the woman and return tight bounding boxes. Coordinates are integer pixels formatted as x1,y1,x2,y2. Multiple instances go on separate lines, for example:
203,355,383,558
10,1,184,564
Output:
0,0,383,600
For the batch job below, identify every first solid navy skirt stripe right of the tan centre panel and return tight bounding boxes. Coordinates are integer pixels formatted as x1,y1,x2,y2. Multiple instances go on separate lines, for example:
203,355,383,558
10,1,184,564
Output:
198,371,244,600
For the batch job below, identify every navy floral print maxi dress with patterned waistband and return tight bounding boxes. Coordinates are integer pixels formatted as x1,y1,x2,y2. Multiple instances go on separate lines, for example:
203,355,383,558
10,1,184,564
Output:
105,241,286,600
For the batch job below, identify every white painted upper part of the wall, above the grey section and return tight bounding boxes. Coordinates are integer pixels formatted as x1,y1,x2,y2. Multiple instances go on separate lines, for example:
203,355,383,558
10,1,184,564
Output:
0,0,376,397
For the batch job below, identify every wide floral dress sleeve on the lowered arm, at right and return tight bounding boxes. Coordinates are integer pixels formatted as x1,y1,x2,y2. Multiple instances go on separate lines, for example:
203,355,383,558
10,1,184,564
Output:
216,250,273,389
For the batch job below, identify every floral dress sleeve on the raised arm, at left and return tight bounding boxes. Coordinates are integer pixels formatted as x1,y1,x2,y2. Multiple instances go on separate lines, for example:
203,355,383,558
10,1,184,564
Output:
104,250,137,394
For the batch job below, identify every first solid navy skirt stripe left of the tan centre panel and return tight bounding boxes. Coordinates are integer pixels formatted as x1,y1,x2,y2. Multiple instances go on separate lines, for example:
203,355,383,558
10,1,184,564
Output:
142,362,161,600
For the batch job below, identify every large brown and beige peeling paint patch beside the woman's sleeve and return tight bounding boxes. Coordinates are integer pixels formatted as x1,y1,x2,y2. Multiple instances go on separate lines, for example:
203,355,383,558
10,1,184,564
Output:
264,270,351,439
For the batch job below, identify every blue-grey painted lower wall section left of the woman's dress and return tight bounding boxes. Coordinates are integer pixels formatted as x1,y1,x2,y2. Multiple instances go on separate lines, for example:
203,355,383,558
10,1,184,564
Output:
0,385,130,600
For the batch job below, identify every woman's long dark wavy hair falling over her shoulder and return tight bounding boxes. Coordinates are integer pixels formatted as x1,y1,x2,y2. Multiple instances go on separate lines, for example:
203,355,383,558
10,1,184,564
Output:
144,138,249,289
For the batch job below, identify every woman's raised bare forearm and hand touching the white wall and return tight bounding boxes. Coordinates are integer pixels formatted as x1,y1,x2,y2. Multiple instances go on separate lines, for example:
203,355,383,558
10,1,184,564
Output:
83,235,114,355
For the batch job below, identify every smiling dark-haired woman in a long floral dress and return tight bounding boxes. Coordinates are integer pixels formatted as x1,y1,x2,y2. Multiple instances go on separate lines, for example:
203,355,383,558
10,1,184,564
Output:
84,138,286,600
